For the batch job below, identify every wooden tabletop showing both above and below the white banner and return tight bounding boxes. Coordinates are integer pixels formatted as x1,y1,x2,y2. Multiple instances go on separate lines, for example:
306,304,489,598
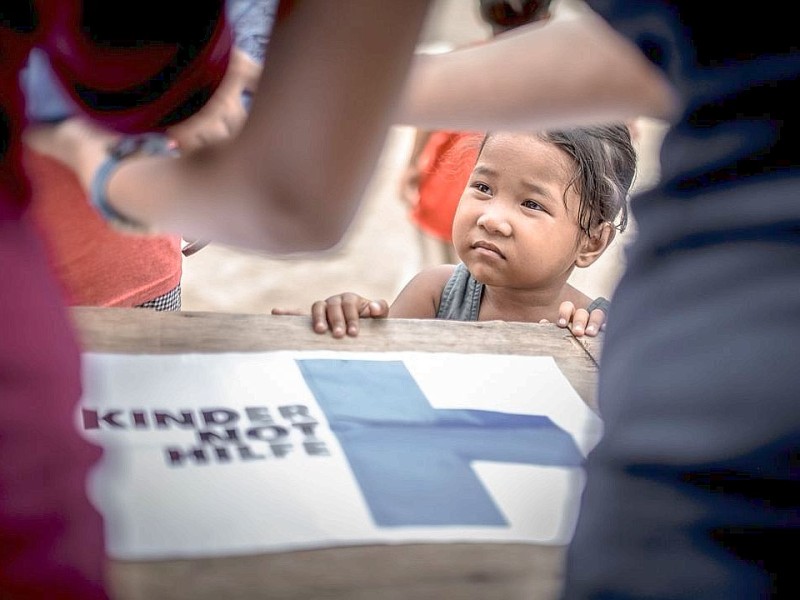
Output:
72,308,597,600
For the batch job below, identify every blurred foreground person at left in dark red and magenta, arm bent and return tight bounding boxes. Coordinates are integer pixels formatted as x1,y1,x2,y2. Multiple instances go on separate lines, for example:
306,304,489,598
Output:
0,0,427,600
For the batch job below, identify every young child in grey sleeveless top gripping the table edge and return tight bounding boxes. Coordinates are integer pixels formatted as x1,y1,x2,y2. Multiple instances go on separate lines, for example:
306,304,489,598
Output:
272,124,636,337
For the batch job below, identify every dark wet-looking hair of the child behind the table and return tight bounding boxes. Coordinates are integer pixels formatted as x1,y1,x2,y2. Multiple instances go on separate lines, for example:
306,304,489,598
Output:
478,123,636,235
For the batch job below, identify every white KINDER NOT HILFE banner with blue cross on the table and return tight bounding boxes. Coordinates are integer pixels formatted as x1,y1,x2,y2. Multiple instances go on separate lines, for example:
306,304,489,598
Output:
81,351,601,559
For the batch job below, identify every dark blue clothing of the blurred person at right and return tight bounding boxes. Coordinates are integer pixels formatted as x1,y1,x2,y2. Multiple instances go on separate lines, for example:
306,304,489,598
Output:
564,0,800,600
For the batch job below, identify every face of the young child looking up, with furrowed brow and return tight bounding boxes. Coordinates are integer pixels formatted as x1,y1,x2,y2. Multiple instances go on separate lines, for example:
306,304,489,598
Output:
453,133,581,289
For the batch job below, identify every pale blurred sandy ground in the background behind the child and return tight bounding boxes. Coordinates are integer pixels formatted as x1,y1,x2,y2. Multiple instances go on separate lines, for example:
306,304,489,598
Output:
182,0,664,313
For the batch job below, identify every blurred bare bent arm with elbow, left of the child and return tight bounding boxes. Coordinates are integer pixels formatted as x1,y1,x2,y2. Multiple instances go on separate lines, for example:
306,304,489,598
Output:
109,0,428,253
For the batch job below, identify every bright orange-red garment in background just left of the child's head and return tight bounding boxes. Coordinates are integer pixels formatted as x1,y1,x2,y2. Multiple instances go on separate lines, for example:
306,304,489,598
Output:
409,131,482,242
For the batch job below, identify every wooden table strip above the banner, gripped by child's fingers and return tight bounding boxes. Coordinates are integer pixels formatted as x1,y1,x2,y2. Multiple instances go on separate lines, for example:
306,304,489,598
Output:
72,308,597,408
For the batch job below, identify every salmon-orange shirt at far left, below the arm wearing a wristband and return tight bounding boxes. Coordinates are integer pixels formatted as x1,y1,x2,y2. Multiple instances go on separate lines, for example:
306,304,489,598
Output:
25,150,181,307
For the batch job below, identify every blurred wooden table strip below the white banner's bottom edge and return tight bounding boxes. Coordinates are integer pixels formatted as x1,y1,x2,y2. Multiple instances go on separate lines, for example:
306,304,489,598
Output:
109,543,564,600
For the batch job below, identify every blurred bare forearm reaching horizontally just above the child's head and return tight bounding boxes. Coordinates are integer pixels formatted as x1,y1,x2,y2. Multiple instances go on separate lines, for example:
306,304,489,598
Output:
398,13,676,134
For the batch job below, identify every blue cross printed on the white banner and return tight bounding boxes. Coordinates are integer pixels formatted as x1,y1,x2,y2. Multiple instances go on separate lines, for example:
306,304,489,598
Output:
297,359,583,527
